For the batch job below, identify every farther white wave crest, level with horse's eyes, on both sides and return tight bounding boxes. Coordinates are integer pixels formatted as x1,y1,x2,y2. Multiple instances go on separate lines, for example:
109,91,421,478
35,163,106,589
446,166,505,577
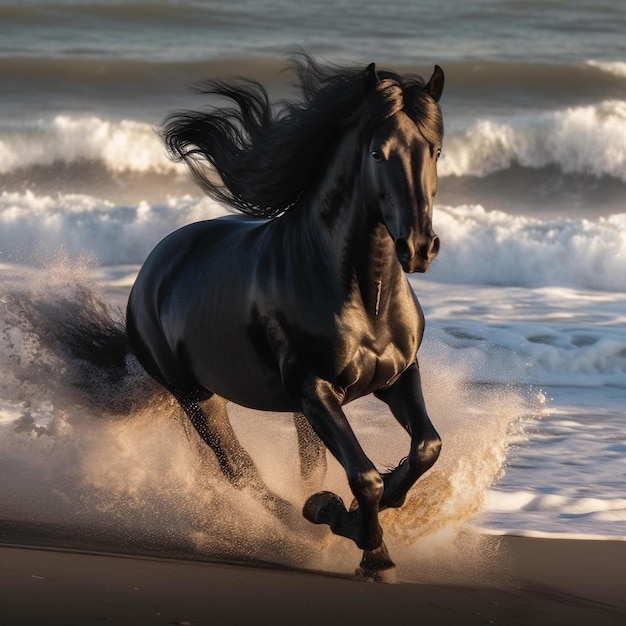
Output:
0,102,626,181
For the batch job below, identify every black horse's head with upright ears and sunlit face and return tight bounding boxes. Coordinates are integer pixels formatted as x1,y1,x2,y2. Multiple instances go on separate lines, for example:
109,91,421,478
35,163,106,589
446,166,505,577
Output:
362,64,444,272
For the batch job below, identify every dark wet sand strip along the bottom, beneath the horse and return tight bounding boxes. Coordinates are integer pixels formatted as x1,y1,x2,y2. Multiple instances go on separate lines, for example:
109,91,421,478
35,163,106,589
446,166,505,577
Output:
0,527,626,626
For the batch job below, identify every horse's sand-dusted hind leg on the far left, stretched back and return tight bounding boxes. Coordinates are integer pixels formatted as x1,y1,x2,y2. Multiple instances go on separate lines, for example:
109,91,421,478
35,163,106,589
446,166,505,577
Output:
174,392,293,518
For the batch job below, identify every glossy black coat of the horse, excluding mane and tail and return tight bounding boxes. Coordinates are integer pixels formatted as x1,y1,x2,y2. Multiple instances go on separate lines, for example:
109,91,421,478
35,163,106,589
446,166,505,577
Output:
127,66,443,575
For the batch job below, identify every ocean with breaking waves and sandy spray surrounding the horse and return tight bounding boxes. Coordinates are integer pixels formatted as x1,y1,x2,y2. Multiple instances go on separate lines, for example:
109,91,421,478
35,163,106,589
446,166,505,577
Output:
0,0,626,566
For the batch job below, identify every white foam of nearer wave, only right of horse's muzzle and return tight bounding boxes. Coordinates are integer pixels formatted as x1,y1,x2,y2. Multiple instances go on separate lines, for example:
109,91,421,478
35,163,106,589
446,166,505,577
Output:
429,205,626,291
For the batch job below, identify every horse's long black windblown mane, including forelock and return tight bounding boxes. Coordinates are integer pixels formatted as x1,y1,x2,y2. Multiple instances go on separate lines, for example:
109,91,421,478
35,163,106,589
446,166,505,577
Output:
161,53,443,218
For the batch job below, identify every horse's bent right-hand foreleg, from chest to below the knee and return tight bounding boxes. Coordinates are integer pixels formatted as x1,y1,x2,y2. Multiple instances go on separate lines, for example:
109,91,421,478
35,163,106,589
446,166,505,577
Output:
375,362,441,509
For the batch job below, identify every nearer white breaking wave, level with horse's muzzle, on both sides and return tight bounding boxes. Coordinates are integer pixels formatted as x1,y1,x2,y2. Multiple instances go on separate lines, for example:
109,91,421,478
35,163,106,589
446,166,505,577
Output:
0,191,626,292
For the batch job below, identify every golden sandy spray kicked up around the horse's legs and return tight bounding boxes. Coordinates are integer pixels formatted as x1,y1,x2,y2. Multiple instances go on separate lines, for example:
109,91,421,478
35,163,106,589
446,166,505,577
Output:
0,267,532,580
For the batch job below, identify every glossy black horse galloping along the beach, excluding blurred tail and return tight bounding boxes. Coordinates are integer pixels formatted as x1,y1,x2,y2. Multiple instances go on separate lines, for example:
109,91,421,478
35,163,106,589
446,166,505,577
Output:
127,55,444,579
